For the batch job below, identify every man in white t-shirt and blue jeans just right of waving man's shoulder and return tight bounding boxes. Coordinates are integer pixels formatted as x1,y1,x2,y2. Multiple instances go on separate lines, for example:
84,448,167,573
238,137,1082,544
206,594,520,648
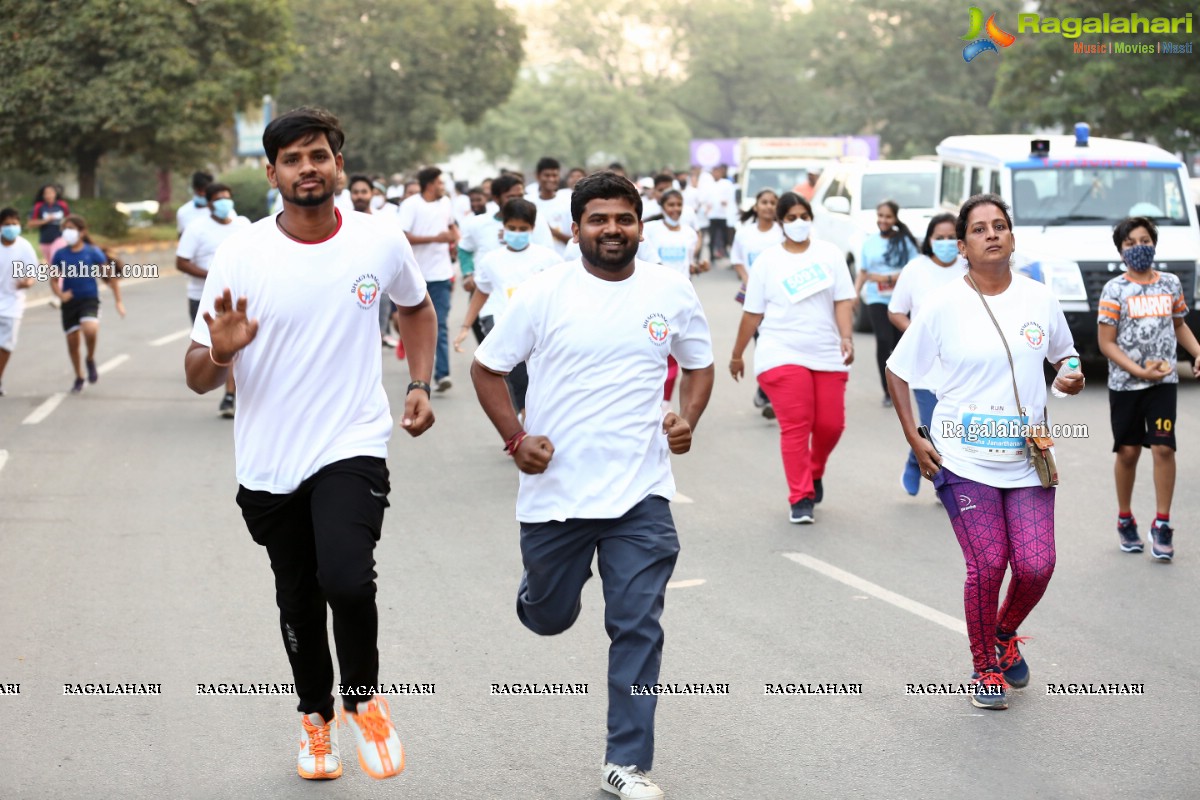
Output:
400,167,458,392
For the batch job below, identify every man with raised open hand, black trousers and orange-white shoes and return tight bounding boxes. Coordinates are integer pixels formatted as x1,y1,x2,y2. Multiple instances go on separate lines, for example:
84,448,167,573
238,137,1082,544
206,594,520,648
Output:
185,108,437,780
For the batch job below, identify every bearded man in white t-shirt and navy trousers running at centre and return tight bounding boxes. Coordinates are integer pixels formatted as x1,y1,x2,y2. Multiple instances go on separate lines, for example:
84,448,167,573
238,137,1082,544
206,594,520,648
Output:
472,173,713,800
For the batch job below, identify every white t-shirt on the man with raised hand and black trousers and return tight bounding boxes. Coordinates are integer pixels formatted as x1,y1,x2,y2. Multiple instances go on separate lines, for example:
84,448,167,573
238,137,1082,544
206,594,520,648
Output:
192,208,425,494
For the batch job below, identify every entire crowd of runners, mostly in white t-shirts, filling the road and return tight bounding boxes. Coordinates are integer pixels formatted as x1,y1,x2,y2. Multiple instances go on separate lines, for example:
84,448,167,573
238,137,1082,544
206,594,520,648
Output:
0,108,1200,799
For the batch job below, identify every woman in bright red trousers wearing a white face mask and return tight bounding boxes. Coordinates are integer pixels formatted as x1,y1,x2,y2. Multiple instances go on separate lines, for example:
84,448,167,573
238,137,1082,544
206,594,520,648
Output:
730,192,854,523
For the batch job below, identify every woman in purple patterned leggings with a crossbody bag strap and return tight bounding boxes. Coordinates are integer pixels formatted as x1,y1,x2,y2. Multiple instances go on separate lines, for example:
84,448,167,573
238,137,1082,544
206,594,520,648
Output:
887,194,1084,709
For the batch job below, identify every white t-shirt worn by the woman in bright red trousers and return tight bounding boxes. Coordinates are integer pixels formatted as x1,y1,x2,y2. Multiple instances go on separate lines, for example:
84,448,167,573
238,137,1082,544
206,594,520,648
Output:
743,240,854,375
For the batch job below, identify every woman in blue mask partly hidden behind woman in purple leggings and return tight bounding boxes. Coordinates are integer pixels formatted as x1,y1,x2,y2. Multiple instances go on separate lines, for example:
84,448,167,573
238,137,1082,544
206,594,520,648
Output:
888,213,967,495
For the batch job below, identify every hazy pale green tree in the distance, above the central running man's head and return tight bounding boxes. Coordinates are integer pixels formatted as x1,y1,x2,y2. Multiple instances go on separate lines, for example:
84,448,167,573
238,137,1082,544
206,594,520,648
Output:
445,64,689,174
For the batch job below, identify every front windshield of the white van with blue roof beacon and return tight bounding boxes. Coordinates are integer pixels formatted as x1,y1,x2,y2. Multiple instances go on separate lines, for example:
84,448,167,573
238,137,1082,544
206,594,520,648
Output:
1013,167,1188,227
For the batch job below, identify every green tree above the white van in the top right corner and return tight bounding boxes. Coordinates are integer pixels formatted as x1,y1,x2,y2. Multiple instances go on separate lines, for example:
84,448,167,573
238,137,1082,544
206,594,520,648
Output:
992,0,1200,160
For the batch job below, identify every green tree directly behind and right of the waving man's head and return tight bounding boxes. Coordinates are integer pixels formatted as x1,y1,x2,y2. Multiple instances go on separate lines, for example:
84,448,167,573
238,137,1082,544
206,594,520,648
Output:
277,0,524,172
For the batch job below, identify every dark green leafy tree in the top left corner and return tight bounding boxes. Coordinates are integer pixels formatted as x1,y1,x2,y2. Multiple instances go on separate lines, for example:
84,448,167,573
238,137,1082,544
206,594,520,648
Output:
0,0,290,197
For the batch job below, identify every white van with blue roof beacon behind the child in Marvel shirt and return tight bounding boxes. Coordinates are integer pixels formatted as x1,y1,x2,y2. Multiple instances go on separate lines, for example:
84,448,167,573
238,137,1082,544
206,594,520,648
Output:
937,124,1200,355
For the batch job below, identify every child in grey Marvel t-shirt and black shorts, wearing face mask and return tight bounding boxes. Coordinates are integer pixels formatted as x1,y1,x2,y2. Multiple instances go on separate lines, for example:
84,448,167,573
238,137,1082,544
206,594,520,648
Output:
1097,217,1200,561
